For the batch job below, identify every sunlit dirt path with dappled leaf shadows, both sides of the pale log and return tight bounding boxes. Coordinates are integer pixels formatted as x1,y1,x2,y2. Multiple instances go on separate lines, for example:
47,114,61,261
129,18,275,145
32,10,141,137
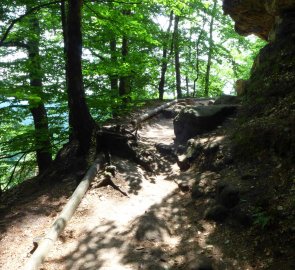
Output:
0,99,259,270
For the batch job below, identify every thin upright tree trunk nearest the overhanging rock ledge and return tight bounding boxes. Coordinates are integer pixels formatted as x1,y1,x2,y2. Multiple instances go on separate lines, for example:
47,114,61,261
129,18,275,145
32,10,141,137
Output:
205,0,217,97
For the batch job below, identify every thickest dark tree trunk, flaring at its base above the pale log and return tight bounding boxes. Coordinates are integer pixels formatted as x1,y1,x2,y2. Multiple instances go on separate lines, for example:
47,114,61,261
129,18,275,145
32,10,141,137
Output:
66,0,94,155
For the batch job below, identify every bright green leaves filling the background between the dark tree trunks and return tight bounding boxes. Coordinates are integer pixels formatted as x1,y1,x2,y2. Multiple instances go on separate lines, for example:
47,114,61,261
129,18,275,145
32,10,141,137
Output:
0,0,264,188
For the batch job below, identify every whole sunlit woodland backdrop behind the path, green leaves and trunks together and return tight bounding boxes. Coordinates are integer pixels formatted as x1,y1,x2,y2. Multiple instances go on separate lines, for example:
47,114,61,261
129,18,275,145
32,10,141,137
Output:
0,0,264,191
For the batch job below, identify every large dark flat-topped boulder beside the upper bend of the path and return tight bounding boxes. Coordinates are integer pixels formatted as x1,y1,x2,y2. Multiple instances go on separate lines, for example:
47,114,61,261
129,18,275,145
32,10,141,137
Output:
173,105,237,144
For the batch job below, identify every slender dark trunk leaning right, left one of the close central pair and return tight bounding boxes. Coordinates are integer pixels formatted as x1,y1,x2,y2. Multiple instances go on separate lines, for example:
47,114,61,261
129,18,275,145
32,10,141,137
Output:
158,11,173,100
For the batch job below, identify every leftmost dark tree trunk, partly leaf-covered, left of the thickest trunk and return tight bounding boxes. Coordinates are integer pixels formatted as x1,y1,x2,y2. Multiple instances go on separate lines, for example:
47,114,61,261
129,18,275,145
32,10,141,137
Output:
28,15,52,173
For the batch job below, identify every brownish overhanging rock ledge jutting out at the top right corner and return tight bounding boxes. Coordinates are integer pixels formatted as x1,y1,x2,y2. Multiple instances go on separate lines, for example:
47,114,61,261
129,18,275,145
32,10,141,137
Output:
223,0,295,40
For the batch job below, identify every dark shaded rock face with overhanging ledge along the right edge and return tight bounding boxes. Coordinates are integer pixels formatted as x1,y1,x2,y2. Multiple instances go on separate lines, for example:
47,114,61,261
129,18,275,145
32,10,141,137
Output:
223,0,295,160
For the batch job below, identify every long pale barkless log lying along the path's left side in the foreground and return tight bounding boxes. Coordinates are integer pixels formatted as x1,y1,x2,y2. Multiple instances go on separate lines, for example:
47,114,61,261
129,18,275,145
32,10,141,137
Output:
24,159,100,270
